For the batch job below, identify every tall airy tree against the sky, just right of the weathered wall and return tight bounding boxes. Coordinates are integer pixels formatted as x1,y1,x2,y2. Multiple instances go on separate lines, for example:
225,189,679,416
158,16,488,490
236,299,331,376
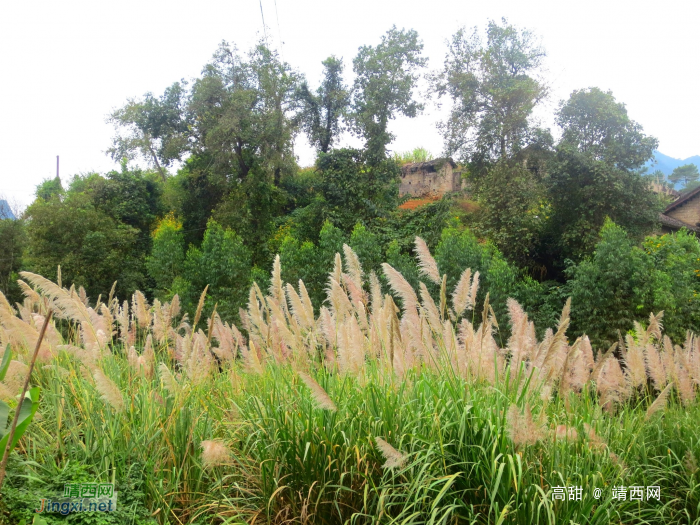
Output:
431,19,547,164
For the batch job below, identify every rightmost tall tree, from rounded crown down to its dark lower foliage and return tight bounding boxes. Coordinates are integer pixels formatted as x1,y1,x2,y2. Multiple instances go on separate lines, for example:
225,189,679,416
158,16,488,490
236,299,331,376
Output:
547,88,661,266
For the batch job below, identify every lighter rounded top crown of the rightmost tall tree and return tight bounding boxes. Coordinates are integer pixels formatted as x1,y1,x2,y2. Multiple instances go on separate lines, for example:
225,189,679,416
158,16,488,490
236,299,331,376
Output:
556,87,659,170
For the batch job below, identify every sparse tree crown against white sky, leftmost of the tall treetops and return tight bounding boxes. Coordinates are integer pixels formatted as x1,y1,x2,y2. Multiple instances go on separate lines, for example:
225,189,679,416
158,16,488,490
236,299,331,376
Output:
107,80,191,180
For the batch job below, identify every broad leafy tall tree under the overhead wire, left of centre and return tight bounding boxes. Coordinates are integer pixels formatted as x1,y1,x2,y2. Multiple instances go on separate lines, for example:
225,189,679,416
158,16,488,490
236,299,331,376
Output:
189,42,298,185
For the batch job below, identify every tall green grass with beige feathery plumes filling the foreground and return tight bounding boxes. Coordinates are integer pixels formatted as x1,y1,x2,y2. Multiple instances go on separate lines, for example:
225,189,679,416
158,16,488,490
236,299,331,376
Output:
0,244,700,525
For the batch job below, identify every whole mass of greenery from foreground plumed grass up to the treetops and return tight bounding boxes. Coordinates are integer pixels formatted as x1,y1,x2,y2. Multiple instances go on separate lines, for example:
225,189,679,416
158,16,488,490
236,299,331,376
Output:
0,19,700,525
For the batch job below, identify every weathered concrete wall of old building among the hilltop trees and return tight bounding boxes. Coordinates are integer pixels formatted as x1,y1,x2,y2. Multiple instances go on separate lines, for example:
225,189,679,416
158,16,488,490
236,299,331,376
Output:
399,159,462,197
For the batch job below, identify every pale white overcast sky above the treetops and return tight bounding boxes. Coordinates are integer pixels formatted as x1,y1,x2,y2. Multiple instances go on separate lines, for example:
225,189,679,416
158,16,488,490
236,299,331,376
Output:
0,0,700,207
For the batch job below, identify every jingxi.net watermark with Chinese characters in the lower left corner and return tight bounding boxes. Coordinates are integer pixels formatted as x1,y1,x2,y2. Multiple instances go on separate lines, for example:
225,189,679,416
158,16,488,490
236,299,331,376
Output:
34,483,117,516
